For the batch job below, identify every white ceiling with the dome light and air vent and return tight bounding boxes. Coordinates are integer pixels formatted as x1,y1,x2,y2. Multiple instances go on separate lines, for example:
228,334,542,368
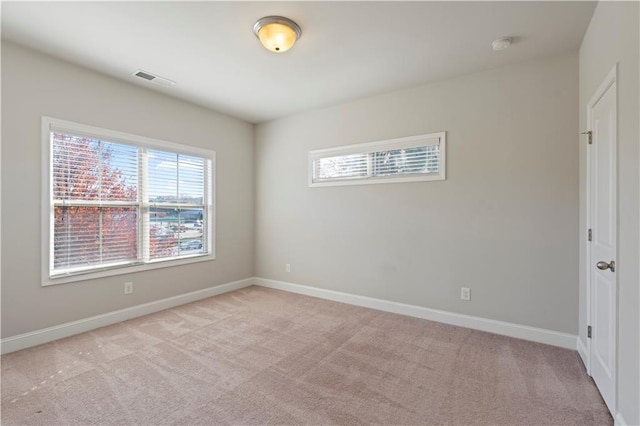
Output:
2,1,595,123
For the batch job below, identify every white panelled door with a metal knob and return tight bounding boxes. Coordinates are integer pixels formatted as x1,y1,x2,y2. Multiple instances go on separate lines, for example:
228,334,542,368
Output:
587,68,617,416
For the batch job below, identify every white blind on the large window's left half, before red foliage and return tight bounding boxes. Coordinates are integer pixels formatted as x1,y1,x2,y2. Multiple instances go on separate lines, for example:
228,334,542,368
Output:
51,135,139,273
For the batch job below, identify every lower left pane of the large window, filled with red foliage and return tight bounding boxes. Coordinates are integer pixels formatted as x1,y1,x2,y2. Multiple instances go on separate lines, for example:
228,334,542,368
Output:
53,206,138,270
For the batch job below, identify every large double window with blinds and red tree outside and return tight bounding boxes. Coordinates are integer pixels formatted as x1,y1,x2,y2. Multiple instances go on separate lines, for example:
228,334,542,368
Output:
43,117,215,285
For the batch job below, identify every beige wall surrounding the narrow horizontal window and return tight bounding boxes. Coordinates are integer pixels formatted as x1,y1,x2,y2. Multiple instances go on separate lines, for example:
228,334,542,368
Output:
255,53,578,334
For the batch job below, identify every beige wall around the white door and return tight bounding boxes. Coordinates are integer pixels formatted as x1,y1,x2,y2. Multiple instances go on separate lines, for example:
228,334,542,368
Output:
579,2,640,425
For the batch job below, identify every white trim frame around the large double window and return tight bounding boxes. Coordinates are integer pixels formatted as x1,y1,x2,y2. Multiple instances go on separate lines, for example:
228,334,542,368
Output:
41,116,216,286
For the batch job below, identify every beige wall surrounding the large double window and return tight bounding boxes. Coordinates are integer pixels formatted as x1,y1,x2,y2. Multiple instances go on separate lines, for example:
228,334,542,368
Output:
2,42,254,338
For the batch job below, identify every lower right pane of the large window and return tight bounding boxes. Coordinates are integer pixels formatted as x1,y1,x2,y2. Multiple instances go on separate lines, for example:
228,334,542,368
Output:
149,208,205,259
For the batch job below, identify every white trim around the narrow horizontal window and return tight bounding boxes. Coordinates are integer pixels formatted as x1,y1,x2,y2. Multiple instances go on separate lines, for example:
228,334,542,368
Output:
308,132,446,187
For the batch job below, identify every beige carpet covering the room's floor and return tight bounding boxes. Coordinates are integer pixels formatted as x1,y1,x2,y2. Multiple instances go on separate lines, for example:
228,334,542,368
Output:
2,287,612,425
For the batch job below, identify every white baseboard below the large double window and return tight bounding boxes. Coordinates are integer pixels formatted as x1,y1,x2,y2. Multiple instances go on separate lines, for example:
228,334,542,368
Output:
0,278,254,354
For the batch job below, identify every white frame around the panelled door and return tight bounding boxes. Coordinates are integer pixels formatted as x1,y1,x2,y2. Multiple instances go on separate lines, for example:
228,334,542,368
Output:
583,63,619,406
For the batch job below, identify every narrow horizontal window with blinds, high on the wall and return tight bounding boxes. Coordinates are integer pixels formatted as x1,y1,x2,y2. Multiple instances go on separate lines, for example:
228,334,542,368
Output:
309,132,446,186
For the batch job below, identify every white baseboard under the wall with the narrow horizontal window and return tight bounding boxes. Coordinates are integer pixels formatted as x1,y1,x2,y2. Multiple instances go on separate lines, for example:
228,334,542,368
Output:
253,277,577,350
